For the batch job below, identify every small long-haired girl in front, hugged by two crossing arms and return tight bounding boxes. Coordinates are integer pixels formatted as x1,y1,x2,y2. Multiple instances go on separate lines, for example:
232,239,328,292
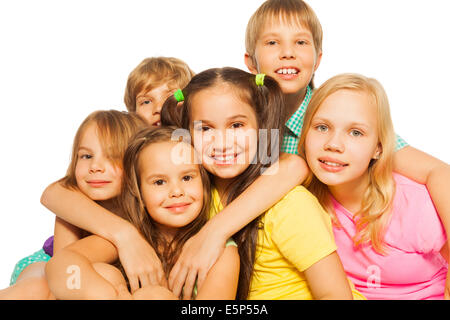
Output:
47,127,239,300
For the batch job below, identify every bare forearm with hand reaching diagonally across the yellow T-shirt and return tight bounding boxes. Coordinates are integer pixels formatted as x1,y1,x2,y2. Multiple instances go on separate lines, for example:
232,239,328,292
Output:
169,154,309,296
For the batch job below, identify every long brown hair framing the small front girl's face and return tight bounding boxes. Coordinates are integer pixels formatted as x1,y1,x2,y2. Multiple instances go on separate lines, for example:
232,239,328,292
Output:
120,127,211,276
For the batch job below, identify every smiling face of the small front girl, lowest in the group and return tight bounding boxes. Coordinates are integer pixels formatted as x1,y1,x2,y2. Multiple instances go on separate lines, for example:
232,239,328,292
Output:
138,141,203,234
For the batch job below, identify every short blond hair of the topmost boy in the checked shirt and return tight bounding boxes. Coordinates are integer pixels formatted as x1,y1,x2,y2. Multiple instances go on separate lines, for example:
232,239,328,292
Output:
245,0,323,89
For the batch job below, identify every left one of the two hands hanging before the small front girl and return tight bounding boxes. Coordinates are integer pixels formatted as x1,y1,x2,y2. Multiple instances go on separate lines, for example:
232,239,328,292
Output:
116,229,167,293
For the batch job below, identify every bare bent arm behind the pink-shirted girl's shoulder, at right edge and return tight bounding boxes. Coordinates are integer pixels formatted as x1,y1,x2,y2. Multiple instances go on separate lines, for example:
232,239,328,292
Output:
394,146,450,299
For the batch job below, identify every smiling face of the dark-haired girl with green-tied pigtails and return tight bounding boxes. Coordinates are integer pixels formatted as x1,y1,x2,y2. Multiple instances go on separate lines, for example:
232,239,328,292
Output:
191,85,258,179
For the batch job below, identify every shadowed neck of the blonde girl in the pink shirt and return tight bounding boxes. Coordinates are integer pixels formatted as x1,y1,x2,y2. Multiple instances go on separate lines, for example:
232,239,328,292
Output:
328,174,369,213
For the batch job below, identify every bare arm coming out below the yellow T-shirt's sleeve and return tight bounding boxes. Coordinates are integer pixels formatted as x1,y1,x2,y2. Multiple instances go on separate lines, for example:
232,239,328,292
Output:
304,251,353,300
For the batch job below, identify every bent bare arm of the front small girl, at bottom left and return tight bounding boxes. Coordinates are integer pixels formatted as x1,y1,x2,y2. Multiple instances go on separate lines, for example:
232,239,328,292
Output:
46,236,125,300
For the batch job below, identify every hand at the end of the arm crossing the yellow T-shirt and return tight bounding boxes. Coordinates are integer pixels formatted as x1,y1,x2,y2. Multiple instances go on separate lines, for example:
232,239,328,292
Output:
169,225,226,300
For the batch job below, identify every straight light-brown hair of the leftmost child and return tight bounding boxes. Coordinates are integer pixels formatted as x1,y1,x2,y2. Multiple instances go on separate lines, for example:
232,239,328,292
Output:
60,110,147,188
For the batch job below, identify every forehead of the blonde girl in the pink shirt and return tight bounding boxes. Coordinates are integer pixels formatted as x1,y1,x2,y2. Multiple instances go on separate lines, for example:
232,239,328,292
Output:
313,89,377,127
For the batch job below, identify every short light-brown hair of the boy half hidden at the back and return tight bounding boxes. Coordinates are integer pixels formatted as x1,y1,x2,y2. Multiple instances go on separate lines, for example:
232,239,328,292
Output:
124,57,194,112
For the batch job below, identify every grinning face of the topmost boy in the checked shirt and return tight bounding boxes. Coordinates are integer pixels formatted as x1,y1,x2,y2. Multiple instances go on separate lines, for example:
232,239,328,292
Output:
245,19,322,94
